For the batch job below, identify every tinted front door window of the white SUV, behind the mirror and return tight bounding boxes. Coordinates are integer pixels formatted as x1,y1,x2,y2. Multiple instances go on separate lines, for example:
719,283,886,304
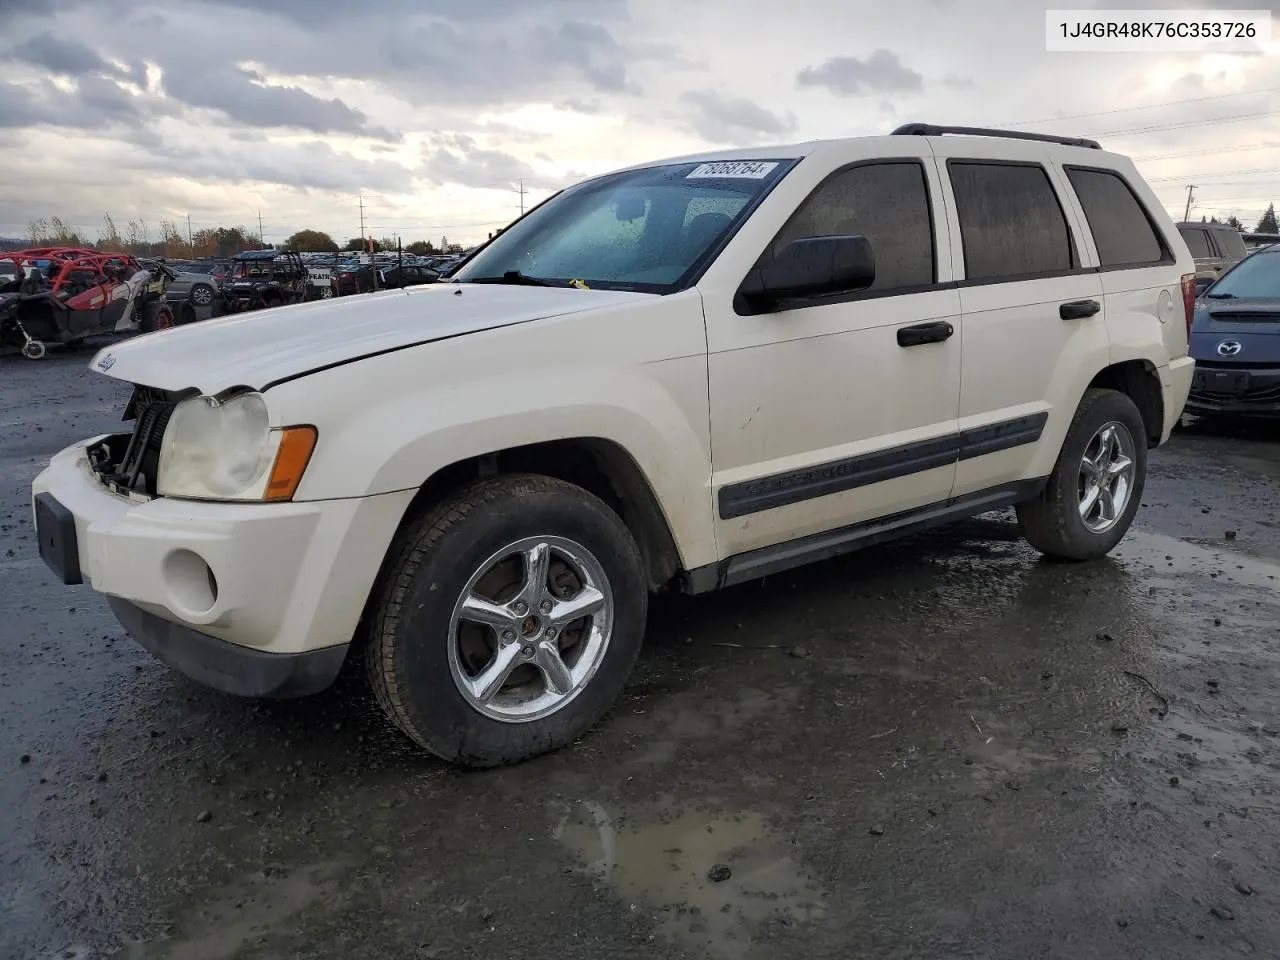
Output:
772,163,934,291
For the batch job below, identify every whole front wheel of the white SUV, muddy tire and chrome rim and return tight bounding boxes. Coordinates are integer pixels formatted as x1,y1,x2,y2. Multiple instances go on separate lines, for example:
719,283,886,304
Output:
364,476,648,767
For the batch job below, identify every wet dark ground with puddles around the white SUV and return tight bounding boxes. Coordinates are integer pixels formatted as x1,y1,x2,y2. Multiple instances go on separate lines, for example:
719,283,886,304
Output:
0,353,1280,960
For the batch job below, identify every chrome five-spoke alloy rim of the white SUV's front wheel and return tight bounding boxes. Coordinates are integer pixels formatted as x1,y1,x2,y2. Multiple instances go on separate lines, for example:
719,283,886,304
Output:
449,536,613,723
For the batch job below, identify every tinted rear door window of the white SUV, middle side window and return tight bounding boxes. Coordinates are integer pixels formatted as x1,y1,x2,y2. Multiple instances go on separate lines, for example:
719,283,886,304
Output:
947,161,1076,280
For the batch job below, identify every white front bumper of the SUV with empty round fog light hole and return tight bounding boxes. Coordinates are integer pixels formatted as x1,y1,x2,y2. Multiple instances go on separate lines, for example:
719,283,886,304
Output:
32,438,412,691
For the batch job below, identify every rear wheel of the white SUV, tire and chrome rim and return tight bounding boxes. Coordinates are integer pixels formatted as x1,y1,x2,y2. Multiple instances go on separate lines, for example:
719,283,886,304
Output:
1018,389,1147,561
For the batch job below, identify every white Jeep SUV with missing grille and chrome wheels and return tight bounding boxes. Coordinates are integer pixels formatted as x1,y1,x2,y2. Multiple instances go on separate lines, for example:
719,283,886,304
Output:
32,124,1196,765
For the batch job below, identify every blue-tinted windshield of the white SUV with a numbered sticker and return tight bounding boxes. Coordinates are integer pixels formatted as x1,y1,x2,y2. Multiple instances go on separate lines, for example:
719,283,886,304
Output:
451,160,791,293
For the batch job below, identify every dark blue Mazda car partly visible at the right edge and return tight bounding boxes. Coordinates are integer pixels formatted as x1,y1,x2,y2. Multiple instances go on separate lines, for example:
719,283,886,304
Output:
1187,244,1280,417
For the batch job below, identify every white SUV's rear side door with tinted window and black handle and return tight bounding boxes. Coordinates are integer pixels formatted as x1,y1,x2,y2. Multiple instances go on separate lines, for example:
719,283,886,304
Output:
934,137,1107,497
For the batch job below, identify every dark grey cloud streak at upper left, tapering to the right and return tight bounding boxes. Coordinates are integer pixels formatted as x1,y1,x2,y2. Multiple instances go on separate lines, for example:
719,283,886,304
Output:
164,67,402,142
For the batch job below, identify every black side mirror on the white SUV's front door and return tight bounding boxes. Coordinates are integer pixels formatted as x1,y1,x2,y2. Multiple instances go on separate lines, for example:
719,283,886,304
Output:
740,237,876,308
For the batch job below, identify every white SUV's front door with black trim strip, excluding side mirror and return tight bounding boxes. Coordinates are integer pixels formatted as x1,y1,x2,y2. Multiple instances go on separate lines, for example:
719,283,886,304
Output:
704,146,960,557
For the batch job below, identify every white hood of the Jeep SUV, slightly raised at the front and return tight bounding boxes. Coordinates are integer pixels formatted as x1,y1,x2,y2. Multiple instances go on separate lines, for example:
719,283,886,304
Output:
90,283,653,394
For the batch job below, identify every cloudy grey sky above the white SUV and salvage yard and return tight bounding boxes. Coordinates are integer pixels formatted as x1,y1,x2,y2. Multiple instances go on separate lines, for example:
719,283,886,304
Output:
0,0,1280,248
